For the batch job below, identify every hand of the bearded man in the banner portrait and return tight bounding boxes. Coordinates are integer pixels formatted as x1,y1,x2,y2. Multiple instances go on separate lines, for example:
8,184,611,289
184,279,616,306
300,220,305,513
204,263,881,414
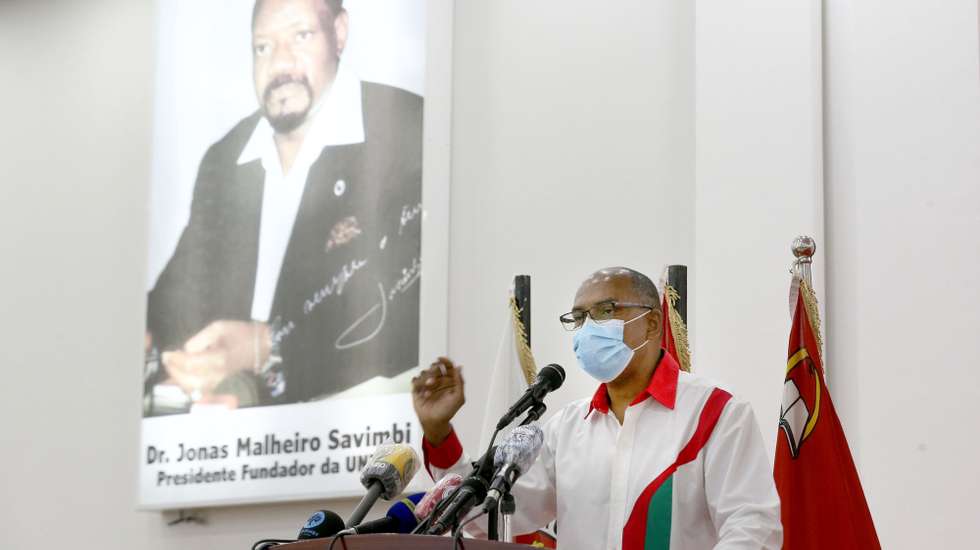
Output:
161,321,271,400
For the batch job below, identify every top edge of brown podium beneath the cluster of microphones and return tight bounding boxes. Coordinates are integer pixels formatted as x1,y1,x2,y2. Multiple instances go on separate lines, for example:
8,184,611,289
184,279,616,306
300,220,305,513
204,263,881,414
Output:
275,535,531,550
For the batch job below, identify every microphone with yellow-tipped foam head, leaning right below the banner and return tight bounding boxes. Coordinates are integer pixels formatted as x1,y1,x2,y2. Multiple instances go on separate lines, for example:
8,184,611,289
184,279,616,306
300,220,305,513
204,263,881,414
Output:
347,443,419,527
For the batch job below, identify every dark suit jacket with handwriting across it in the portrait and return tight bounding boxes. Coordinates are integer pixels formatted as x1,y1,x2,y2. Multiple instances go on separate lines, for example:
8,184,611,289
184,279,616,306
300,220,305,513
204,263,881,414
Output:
147,82,422,410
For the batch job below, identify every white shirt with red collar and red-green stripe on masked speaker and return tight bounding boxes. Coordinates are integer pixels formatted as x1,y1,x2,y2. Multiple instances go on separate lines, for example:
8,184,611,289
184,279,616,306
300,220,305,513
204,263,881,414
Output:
423,353,782,550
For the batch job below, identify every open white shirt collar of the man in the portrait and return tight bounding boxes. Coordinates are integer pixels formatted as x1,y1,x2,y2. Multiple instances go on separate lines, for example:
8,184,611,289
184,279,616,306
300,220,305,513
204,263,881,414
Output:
238,62,364,169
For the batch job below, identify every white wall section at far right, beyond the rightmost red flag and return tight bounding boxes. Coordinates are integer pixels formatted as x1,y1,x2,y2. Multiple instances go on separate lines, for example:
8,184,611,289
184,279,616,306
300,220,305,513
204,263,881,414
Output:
826,0,980,549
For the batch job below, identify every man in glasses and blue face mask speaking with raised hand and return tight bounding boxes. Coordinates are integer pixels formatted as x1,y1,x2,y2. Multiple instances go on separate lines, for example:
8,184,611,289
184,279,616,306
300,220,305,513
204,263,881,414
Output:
413,267,782,550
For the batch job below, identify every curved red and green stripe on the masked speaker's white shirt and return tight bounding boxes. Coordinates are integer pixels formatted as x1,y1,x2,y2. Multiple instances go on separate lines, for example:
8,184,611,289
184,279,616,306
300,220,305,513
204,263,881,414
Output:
623,388,732,550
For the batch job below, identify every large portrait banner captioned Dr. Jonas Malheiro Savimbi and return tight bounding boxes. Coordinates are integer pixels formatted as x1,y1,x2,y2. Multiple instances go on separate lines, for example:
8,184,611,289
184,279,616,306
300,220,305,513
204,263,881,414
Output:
140,0,429,508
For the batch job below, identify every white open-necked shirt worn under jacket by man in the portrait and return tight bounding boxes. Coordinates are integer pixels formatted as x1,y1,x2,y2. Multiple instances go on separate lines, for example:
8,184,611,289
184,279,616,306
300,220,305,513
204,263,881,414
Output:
238,63,364,321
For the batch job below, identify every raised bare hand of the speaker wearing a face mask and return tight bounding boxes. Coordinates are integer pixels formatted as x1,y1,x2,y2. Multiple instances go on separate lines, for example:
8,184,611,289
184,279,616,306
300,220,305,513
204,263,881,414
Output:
412,357,466,445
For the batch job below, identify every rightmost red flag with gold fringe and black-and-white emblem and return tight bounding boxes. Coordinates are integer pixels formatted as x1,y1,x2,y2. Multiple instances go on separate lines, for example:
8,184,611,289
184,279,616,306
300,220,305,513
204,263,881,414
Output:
773,285,881,550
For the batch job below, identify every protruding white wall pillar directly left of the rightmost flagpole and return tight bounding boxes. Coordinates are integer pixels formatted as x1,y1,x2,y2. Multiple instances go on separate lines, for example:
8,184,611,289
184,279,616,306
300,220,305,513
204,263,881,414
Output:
691,0,824,462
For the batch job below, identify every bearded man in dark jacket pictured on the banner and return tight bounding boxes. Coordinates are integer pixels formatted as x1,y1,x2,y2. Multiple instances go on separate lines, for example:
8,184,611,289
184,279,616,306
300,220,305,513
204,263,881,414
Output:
144,0,422,415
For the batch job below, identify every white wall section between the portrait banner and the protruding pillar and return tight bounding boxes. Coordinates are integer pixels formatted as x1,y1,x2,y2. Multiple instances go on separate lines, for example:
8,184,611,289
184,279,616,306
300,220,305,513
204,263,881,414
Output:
449,0,694,448
